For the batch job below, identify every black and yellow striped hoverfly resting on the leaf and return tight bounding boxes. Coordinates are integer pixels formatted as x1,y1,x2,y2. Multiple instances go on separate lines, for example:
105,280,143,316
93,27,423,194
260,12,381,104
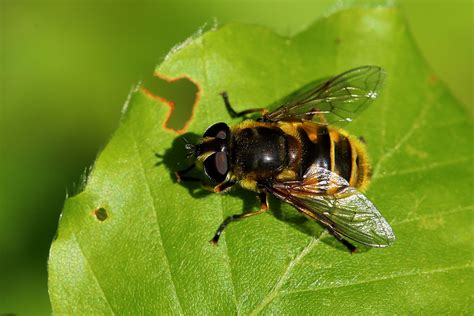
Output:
176,66,395,251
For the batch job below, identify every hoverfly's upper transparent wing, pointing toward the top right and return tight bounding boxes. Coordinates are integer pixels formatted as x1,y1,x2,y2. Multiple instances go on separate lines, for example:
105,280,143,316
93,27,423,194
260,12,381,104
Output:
262,66,385,125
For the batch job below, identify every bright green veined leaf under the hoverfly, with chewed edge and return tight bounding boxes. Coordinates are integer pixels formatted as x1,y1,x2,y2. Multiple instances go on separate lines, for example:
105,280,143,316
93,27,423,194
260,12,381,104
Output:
49,7,474,314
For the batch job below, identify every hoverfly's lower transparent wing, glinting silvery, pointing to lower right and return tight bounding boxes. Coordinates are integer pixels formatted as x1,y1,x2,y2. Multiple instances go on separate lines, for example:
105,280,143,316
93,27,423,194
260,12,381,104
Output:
267,167,395,247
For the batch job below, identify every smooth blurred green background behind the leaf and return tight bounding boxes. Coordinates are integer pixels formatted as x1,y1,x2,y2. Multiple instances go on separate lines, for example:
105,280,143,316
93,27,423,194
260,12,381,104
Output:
0,0,473,314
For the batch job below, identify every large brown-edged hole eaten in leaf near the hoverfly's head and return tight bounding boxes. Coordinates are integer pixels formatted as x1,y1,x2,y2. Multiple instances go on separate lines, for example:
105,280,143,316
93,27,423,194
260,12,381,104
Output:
141,73,201,134
